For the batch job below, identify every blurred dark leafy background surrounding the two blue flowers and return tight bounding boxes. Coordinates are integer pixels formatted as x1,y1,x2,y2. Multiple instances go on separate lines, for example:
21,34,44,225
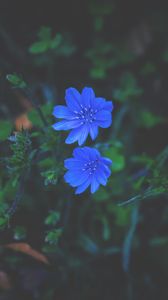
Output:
0,0,168,300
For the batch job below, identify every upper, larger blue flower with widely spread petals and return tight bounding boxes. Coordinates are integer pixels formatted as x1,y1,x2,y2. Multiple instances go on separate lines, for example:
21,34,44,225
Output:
52,87,113,146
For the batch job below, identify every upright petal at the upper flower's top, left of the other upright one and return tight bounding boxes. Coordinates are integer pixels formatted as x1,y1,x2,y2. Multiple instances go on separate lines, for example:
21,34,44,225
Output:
65,88,81,112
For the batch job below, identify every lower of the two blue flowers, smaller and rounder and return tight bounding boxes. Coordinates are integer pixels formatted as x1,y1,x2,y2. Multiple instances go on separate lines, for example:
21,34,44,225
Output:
64,147,112,194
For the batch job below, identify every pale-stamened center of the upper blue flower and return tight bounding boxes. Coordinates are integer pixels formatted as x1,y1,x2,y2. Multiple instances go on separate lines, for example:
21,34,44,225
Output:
74,105,97,124
